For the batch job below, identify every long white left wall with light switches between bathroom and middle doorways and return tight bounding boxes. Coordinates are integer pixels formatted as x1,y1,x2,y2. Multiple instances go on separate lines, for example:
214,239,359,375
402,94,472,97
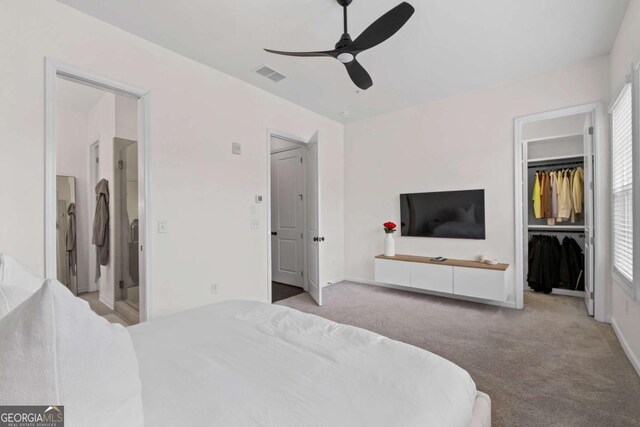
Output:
0,0,344,315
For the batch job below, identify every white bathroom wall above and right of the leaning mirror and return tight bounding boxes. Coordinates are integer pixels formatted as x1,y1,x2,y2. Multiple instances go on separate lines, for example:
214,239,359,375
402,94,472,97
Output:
56,106,93,292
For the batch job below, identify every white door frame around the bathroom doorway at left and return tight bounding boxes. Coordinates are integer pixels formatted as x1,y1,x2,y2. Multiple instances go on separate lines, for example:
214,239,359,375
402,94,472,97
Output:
44,57,153,322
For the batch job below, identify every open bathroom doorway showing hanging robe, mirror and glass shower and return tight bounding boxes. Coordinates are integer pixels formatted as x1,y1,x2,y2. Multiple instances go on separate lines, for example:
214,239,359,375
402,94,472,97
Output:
46,61,148,326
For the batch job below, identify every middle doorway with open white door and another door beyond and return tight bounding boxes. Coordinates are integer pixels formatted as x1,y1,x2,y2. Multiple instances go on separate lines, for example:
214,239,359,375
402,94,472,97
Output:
268,132,324,305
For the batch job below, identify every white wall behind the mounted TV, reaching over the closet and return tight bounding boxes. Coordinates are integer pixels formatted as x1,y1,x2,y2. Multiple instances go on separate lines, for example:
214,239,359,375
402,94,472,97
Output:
345,57,609,304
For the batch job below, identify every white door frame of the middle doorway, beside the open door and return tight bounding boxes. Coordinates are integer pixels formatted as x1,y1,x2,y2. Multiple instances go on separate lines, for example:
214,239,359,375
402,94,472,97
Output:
266,129,320,304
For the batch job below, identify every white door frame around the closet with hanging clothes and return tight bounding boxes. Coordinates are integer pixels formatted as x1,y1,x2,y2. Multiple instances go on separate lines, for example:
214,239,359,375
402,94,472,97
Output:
513,102,608,322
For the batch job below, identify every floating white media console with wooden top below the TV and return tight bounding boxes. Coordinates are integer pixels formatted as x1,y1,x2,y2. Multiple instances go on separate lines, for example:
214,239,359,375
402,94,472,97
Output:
375,255,509,302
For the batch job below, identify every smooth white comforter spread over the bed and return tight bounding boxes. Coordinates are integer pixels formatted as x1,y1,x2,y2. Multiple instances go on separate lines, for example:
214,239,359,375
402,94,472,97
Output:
129,301,476,427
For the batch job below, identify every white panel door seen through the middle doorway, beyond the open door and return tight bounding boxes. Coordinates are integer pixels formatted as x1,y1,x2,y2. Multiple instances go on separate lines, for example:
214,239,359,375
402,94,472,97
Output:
271,148,304,287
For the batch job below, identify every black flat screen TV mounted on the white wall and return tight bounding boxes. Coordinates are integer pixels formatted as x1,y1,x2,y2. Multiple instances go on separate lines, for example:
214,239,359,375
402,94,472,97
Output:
400,190,485,240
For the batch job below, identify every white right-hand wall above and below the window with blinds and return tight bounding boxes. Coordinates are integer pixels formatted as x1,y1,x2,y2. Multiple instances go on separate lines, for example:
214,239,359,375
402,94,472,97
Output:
610,0,640,373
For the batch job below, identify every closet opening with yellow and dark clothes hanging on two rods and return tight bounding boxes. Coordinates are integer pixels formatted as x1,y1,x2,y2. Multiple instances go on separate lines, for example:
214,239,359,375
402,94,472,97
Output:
515,104,606,320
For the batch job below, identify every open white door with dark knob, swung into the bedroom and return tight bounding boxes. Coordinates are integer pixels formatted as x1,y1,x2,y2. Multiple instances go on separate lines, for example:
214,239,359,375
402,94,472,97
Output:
305,132,324,305
